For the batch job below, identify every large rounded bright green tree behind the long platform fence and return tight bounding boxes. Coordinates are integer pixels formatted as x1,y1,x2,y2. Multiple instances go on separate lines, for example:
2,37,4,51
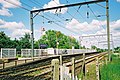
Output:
35,30,79,49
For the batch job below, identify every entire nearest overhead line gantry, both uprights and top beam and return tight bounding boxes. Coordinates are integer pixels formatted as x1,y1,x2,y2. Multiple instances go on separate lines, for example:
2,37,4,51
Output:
30,0,111,61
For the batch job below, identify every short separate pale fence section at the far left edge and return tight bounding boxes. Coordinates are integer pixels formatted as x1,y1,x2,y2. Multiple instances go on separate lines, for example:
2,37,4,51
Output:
0,48,16,58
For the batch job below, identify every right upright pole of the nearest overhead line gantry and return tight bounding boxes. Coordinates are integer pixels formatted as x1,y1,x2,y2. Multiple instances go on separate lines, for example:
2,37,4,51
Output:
106,0,111,61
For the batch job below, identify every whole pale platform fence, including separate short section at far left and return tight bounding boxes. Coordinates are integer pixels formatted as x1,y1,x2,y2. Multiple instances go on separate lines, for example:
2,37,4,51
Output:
0,48,96,58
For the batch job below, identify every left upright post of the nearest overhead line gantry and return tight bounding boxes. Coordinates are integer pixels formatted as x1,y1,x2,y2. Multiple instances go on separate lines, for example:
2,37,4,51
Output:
30,11,34,57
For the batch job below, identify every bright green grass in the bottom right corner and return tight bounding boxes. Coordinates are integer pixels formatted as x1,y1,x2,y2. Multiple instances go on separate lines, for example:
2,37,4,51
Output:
100,55,120,80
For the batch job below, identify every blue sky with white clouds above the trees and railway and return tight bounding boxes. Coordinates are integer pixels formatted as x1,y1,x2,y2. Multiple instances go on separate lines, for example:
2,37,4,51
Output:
0,0,120,48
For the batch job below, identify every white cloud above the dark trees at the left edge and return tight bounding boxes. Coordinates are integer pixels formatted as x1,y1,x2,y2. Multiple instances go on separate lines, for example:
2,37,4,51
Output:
0,19,31,39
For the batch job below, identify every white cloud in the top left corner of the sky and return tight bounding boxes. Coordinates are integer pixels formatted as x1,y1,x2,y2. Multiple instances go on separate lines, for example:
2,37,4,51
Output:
0,0,21,16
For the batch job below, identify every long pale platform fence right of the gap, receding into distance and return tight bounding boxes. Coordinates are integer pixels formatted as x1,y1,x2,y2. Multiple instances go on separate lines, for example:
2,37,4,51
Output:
21,48,96,57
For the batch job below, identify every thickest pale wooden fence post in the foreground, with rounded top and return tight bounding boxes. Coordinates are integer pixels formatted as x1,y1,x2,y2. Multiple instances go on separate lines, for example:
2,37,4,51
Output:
52,59,59,80
